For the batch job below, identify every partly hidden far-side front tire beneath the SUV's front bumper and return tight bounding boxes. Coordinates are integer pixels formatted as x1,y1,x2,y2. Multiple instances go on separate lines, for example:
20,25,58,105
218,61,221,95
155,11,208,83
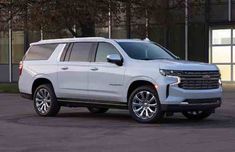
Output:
182,110,212,120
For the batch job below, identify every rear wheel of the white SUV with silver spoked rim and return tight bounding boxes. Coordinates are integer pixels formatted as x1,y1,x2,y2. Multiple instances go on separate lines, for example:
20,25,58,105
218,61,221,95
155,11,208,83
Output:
33,84,60,117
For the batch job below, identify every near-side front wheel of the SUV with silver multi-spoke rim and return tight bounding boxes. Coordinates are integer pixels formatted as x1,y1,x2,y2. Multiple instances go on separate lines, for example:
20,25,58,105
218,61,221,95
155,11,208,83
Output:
128,86,164,123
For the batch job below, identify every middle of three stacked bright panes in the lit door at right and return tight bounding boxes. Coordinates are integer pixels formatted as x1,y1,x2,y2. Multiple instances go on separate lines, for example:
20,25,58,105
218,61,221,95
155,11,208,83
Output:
212,46,231,63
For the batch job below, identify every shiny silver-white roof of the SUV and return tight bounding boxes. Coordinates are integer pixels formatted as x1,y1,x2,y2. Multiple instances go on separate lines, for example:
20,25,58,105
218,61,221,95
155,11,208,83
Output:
30,37,149,45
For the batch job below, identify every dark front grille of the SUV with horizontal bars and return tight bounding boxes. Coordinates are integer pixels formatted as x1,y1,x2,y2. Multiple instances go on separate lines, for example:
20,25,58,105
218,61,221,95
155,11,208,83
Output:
177,71,220,90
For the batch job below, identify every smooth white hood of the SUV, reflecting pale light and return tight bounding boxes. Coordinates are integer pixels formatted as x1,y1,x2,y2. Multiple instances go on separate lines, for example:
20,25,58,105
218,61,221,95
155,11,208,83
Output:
149,59,218,71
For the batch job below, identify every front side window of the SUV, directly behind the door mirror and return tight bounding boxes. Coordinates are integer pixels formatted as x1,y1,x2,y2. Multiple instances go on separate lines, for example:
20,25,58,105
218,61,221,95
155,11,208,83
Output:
95,43,119,62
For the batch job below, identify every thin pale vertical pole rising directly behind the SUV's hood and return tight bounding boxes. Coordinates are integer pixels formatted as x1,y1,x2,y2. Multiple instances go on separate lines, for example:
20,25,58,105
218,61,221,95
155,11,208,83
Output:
185,0,188,60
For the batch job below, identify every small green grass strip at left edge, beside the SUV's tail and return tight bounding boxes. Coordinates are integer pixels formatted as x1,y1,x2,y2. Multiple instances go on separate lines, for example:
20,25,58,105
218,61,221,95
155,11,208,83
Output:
0,83,19,93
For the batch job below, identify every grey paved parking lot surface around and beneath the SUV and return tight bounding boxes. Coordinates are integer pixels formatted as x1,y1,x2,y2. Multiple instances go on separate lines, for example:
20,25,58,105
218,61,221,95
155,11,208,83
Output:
0,86,235,152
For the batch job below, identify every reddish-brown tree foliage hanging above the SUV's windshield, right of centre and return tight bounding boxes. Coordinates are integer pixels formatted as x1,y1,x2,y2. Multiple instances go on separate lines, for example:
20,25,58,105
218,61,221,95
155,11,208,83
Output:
126,0,205,37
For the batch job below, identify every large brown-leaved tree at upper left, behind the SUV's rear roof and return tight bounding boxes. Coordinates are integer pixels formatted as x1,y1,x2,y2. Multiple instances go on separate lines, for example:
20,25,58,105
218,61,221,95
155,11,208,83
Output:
0,0,119,37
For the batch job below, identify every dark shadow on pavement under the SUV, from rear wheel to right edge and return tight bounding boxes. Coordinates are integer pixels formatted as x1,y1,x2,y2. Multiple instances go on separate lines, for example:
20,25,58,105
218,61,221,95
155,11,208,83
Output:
54,112,235,129
